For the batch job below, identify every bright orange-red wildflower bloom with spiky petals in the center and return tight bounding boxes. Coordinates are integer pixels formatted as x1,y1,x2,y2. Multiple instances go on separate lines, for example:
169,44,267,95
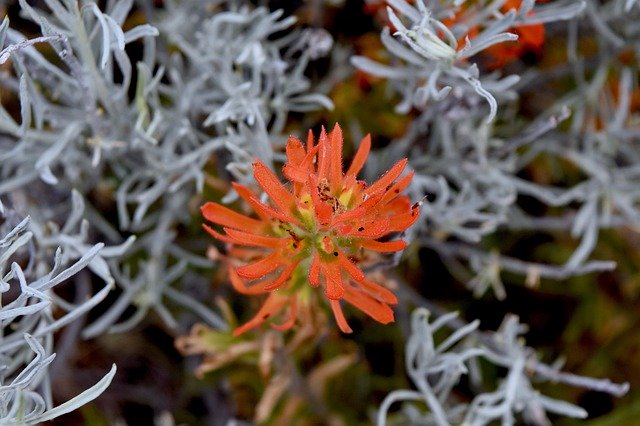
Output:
202,125,419,335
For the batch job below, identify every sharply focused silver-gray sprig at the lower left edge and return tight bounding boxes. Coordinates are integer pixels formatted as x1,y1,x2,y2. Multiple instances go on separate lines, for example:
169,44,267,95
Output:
0,208,116,425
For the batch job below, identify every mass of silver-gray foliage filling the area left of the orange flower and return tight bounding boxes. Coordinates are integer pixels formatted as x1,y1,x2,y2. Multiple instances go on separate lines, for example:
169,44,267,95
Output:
0,0,332,424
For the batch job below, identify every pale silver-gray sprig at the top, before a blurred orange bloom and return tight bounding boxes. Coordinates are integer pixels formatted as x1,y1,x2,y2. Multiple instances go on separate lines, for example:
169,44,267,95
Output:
353,0,584,122
